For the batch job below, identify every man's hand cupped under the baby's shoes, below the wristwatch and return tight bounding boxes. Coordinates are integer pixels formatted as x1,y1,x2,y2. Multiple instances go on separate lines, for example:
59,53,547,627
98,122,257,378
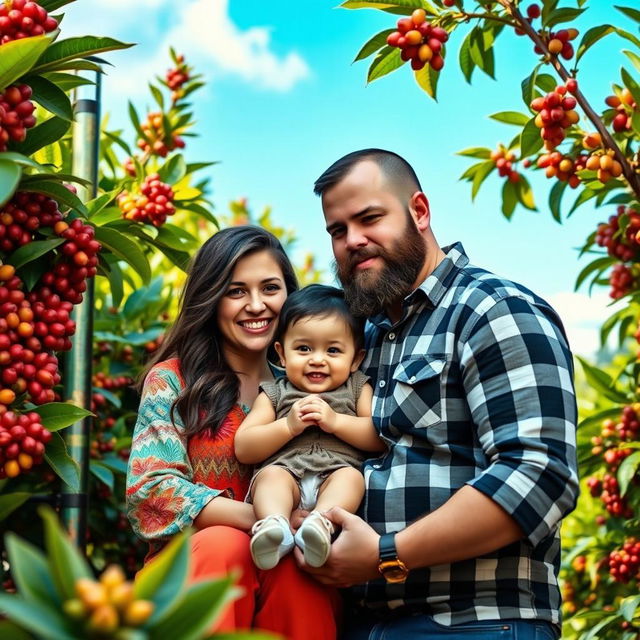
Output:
295,507,380,587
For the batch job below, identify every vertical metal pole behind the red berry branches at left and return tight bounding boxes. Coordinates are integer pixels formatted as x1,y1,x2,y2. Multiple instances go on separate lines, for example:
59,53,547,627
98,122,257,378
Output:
61,73,101,551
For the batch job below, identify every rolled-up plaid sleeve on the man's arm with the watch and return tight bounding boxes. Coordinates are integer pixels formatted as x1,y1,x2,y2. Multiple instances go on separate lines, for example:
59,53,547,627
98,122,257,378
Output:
461,297,579,545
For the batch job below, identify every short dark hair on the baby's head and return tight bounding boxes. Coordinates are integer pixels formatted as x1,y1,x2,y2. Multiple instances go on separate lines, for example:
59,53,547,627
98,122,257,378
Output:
275,284,365,352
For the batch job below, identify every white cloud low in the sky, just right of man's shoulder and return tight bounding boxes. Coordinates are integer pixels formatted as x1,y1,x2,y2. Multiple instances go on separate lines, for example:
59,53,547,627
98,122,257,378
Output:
546,291,617,356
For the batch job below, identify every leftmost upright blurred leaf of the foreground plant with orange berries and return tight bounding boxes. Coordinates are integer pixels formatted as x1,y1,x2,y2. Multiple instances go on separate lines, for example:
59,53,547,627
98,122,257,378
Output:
5,532,62,607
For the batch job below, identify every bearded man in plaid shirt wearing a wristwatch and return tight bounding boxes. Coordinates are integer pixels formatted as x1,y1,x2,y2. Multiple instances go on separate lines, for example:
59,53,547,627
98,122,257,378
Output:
298,149,578,640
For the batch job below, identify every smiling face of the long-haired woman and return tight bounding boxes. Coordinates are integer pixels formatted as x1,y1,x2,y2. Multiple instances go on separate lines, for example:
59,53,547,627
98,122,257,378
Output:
217,250,287,355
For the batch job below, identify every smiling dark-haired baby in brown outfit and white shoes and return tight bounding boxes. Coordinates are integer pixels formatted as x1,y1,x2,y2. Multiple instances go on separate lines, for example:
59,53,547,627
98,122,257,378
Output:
235,284,385,569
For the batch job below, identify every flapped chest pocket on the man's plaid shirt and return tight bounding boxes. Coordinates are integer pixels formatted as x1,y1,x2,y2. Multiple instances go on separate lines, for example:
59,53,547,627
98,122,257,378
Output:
391,356,446,432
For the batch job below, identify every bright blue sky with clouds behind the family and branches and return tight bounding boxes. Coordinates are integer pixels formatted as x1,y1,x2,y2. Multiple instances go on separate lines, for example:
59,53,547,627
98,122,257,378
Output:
62,0,636,353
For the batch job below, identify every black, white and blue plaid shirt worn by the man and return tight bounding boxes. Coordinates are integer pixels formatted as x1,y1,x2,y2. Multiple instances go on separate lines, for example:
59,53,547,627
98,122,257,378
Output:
354,244,578,625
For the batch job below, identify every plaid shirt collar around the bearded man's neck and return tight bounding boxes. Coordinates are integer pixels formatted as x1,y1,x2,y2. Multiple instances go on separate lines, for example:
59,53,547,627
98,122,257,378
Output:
369,242,469,328
